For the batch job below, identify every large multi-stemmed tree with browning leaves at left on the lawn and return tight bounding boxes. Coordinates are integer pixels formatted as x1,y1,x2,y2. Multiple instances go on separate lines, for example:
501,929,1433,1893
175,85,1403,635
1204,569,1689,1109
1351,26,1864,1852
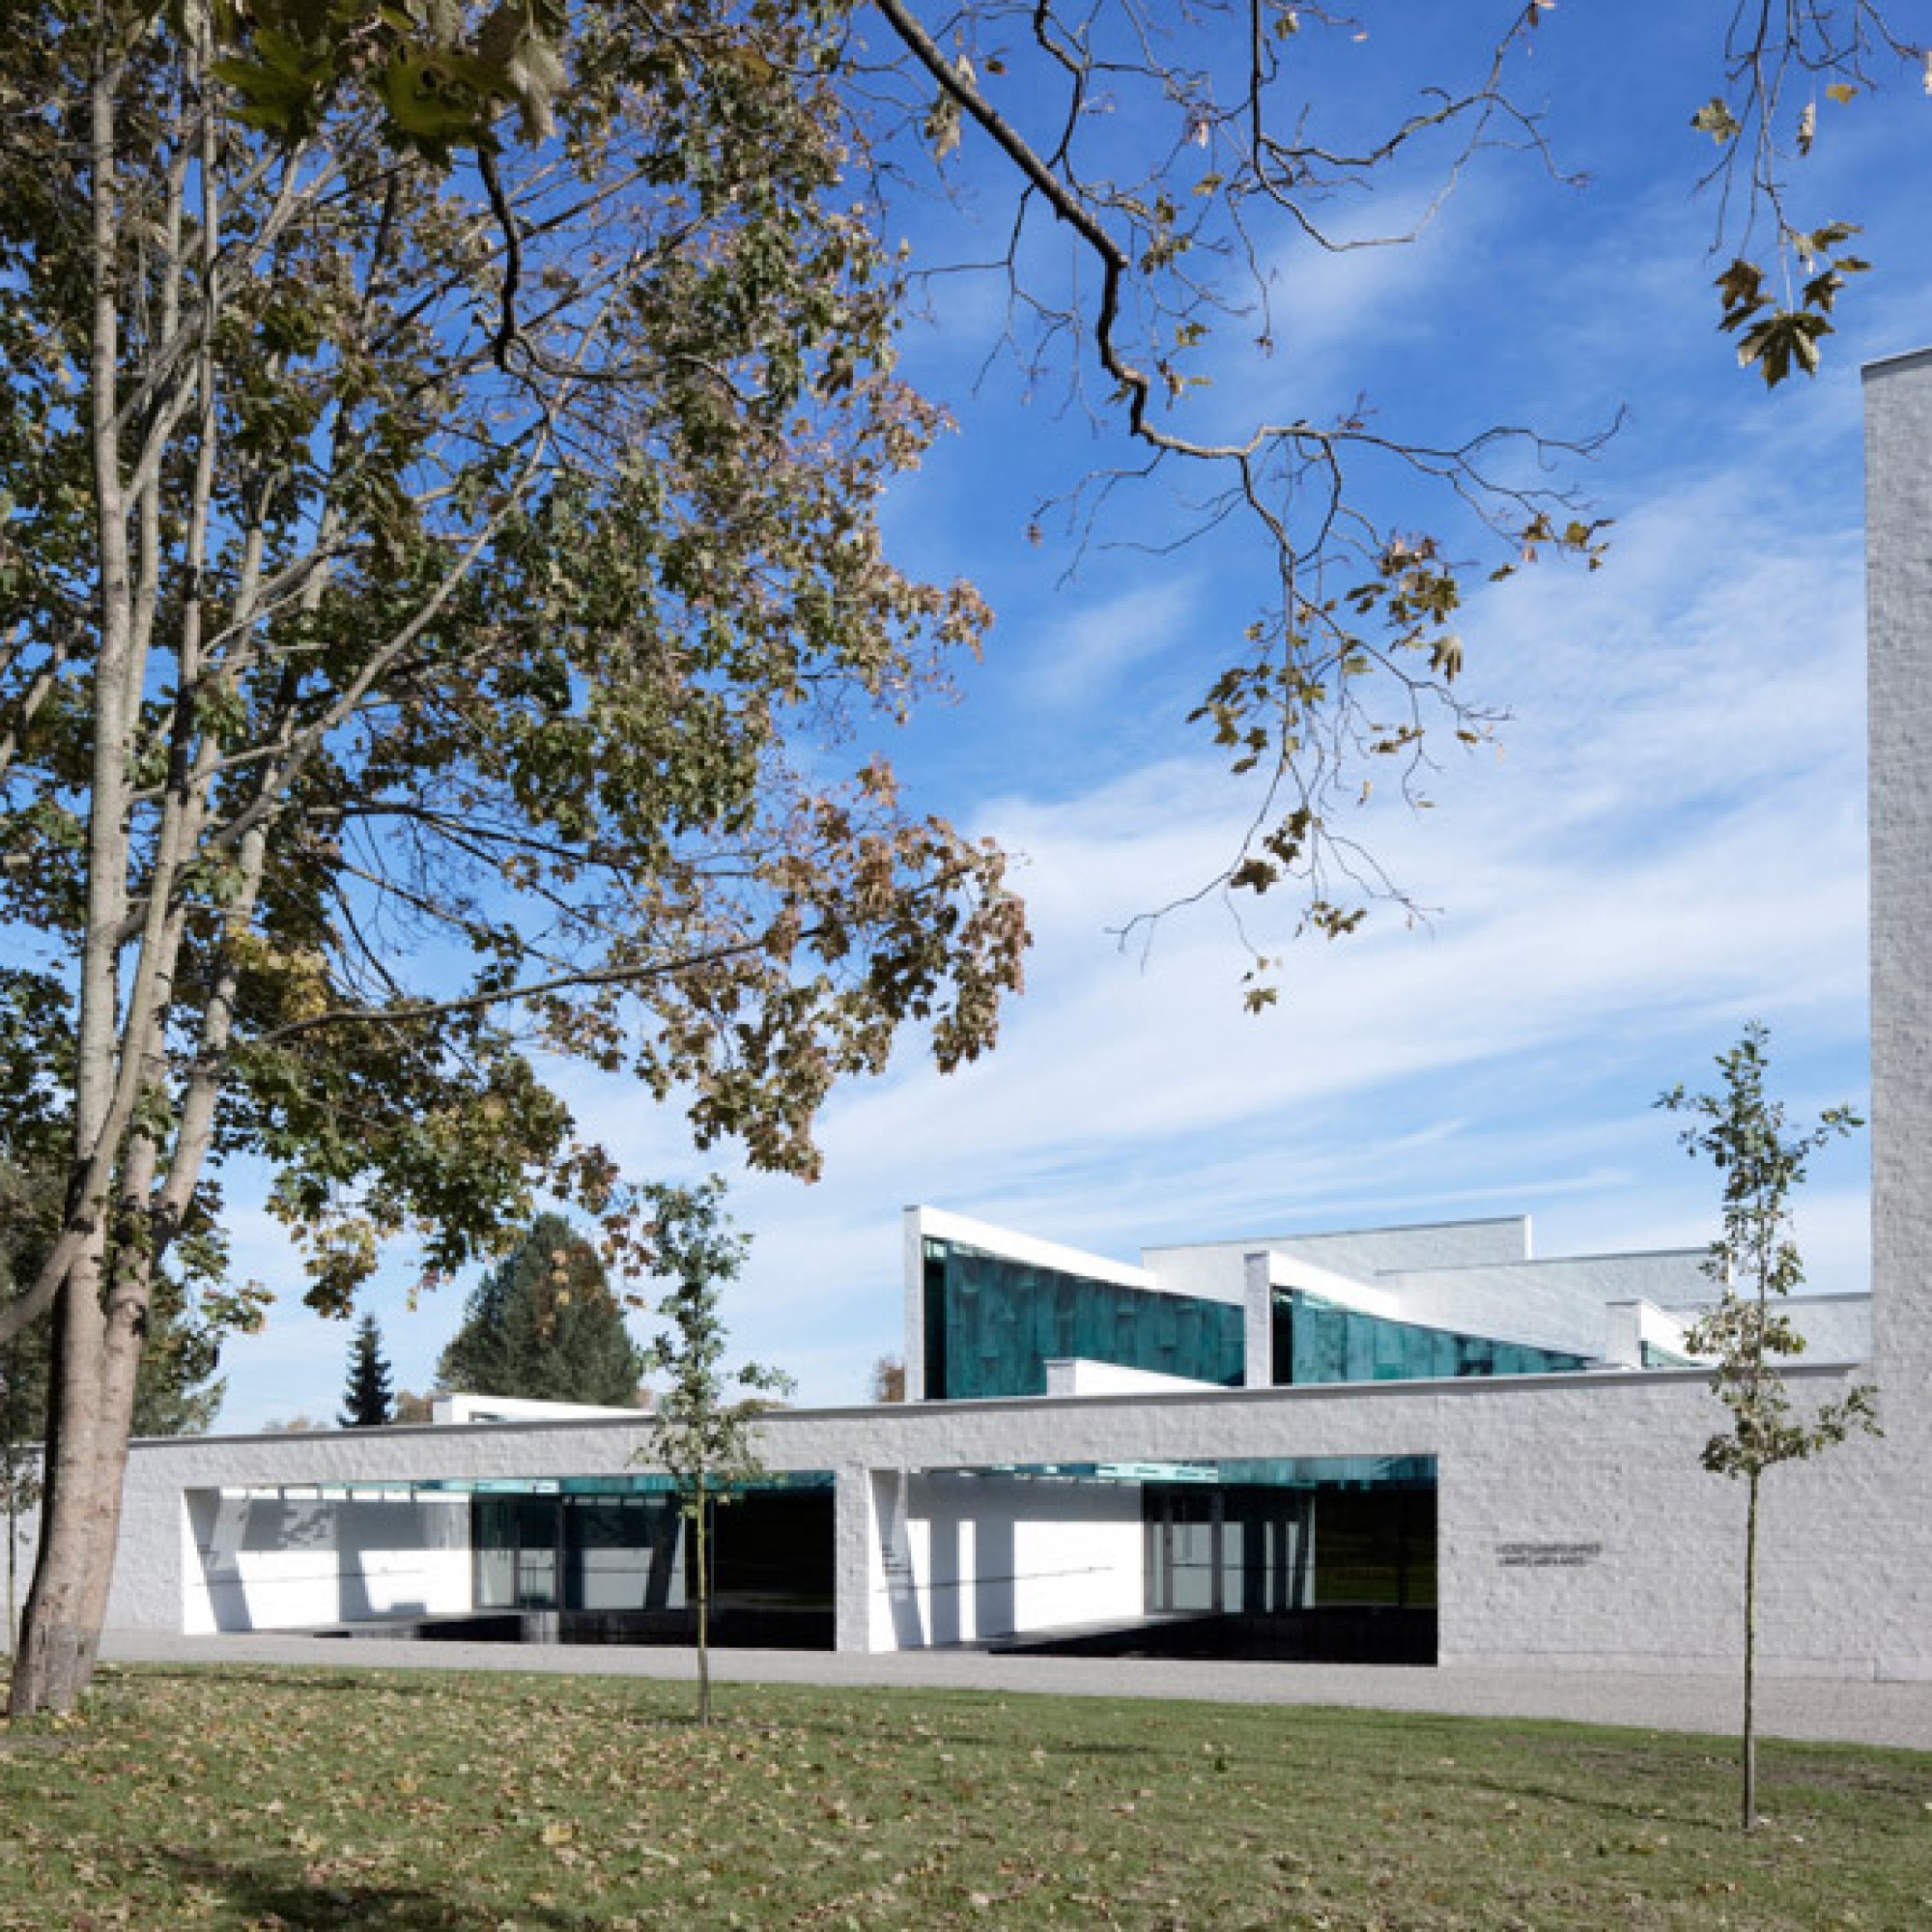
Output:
0,0,1024,1712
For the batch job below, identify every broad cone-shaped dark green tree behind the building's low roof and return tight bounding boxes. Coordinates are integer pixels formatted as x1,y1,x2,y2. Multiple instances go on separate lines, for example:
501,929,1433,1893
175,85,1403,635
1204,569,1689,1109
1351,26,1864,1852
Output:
437,1213,643,1408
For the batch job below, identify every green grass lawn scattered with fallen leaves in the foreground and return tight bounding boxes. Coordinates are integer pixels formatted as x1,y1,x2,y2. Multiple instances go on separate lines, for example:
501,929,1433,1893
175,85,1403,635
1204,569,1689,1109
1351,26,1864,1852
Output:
0,1667,1932,1932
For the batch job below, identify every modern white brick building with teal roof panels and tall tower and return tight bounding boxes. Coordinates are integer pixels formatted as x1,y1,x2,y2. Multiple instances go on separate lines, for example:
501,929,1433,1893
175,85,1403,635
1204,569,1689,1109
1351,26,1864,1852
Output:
14,352,1932,1679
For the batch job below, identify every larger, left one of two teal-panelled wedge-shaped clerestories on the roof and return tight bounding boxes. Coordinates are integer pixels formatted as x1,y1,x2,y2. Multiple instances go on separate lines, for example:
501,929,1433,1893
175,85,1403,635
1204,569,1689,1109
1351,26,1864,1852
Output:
923,1240,1242,1401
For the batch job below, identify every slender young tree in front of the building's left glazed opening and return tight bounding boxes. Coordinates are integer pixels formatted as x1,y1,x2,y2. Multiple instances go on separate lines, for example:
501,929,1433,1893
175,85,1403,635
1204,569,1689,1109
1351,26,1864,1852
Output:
639,1179,792,1723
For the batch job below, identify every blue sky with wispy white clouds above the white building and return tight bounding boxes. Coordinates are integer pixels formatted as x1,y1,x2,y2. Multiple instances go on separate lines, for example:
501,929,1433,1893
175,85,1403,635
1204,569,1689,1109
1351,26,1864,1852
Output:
204,4,1932,1428
